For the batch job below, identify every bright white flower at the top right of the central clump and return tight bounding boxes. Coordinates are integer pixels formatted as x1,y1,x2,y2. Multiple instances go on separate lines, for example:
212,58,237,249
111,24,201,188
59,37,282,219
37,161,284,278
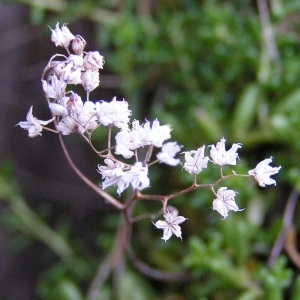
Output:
142,120,171,148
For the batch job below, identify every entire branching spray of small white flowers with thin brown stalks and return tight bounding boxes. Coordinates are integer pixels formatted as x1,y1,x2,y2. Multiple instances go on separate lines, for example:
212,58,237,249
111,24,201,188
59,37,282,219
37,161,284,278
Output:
17,23,281,241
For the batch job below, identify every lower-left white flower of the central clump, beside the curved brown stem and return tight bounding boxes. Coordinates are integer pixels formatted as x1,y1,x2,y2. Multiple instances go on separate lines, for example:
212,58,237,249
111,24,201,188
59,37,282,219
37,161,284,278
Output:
98,158,129,195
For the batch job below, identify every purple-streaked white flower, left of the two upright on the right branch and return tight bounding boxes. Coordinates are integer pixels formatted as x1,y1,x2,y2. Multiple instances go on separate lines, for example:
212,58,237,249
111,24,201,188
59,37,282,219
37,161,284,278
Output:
183,146,209,175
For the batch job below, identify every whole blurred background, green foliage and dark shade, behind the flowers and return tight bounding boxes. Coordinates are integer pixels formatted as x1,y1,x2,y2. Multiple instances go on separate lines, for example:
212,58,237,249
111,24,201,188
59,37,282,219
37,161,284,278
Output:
0,0,300,300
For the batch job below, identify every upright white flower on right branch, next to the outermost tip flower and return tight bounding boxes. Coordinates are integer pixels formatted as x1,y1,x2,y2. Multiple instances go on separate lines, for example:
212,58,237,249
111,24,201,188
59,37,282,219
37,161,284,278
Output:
210,138,242,166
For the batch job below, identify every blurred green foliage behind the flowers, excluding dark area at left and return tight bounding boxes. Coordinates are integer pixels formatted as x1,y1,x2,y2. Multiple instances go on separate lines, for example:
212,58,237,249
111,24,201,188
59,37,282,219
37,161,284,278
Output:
1,0,300,300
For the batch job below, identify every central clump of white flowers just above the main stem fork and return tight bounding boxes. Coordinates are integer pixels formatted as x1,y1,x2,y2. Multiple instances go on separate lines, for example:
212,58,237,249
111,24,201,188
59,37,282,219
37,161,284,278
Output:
98,120,180,194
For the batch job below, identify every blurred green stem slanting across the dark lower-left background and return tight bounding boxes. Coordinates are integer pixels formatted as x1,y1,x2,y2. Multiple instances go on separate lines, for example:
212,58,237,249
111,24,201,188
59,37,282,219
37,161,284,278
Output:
0,177,86,277
